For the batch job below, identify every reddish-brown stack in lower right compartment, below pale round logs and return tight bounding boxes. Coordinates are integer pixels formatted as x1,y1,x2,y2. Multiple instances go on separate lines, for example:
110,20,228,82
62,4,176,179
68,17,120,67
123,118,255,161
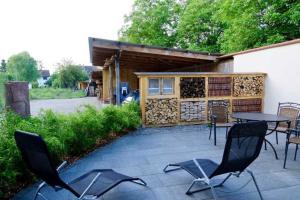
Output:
232,98,262,112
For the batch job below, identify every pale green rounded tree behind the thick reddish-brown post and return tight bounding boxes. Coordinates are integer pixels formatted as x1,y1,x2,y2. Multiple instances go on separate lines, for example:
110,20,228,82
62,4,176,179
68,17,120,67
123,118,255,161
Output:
7,52,40,82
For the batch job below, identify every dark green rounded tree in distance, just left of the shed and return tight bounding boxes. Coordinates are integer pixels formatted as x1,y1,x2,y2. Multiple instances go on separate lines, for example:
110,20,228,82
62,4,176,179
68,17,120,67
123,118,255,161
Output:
52,60,88,89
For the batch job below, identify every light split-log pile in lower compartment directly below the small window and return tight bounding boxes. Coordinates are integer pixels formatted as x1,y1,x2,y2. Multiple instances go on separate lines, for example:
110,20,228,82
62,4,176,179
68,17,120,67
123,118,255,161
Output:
145,98,178,125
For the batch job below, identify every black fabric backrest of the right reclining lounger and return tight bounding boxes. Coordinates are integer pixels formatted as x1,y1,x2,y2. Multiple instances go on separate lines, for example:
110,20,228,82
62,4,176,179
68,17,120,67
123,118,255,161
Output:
211,122,268,177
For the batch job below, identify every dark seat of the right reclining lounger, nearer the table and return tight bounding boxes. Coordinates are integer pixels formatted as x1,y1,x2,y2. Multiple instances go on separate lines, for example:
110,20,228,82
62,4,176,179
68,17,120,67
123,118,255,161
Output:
176,159,219,178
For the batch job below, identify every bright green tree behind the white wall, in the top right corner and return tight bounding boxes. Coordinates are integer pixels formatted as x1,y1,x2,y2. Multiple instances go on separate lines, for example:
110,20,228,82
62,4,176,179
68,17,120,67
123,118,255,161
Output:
216,0,300,53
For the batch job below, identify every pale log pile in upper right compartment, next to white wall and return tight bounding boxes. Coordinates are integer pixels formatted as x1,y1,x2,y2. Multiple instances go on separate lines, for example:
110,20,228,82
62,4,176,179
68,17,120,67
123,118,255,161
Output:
233,76,264,97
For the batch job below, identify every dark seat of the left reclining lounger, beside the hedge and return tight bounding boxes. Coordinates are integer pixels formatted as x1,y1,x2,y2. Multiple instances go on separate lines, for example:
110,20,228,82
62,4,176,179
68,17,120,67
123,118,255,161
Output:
69,169,132,196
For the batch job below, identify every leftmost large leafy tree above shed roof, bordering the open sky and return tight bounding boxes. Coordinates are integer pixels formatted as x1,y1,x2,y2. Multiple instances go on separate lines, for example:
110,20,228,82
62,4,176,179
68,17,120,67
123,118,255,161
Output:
119,0,184,47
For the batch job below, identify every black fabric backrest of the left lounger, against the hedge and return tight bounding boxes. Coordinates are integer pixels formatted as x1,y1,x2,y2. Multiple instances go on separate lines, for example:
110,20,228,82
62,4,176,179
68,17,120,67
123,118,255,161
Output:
15,131,78,196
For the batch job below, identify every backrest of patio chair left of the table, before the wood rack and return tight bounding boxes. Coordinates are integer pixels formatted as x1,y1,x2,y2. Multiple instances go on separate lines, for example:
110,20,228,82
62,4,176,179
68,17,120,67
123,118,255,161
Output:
209,101,229,123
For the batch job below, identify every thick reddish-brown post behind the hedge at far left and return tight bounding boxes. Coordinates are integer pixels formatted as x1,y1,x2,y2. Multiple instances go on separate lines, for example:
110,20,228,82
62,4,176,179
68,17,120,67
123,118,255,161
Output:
5,81,30,117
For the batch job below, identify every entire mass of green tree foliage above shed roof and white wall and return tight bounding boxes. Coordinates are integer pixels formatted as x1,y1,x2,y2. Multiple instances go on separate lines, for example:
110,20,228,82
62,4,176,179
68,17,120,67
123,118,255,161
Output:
119,0,300,53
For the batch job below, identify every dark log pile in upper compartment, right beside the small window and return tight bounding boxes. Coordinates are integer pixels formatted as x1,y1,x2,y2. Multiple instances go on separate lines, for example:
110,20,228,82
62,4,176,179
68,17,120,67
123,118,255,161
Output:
180,77,205,98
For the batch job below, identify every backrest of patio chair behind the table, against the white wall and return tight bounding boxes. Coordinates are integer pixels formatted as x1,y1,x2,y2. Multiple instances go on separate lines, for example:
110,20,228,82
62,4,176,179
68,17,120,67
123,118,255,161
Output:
277,102,300,128
